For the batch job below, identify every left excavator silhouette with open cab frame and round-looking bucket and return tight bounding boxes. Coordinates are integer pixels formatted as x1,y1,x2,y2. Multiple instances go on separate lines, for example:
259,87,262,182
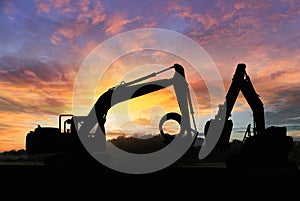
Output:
26,64,198,154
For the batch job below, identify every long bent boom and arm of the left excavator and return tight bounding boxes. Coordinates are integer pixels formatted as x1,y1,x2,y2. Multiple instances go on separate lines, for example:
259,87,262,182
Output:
73,64,194,152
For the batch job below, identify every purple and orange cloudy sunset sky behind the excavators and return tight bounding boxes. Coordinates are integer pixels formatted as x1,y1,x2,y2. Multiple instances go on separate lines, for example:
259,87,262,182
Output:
0,0,300,151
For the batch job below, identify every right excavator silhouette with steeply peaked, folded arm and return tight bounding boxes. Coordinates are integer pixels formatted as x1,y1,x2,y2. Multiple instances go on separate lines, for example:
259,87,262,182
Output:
204,63,293,169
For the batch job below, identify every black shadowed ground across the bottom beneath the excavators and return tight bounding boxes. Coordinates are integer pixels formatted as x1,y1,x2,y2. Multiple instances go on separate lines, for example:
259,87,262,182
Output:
0,150,300,196
